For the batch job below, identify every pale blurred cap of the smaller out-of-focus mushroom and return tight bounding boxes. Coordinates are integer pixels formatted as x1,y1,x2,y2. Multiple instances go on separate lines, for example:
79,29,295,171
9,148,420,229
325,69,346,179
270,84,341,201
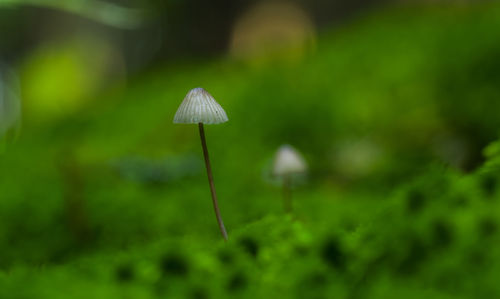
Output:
273,144,307,176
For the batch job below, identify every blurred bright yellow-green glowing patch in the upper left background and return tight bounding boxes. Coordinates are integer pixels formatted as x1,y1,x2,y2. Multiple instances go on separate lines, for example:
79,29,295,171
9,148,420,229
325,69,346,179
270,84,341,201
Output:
21,37,123,120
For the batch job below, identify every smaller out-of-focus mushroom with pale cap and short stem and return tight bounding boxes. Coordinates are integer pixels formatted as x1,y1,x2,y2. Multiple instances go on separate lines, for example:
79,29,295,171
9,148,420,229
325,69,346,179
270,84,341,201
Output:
273,144,307,213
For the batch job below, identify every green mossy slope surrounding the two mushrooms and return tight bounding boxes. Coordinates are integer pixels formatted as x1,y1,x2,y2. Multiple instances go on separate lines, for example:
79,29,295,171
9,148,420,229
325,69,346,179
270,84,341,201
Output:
0,4,500,298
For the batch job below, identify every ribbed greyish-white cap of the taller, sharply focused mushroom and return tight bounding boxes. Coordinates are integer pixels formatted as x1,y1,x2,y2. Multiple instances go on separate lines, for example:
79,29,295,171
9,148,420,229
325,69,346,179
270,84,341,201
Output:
174,87,228,124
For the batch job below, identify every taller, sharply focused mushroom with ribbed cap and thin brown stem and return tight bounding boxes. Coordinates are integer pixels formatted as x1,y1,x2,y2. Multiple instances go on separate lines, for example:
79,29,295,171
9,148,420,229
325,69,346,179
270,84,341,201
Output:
174,88,228,241
